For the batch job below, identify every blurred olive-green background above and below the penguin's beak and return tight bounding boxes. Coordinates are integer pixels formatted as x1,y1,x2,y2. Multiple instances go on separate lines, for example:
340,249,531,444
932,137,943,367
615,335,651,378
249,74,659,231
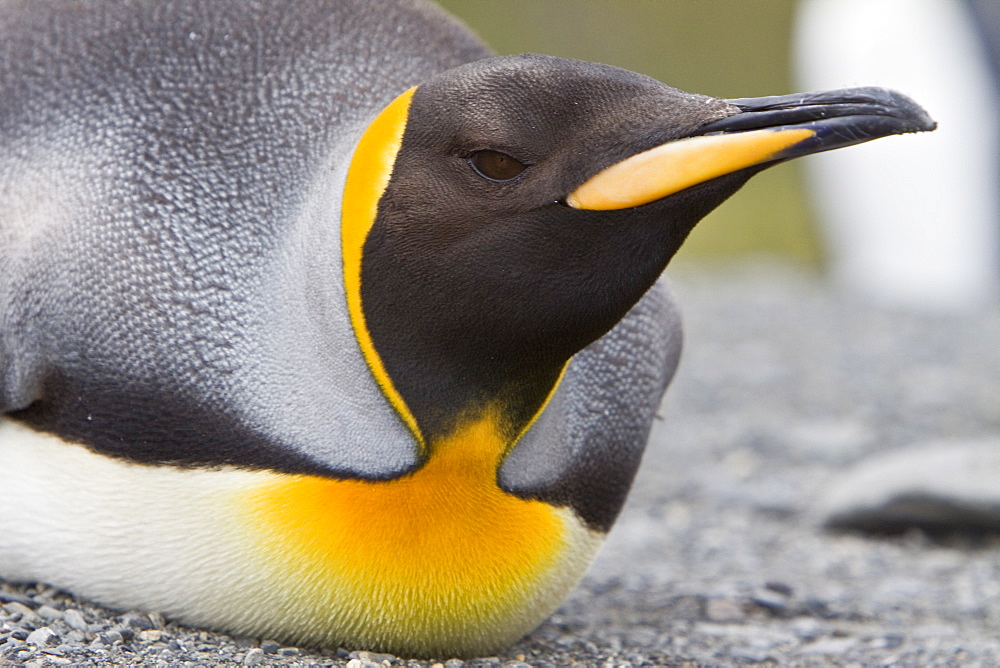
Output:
440,0,821,267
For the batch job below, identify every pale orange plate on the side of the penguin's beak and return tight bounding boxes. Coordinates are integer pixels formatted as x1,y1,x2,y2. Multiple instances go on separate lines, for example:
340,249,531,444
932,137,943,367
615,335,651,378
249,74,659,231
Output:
566,128,816,211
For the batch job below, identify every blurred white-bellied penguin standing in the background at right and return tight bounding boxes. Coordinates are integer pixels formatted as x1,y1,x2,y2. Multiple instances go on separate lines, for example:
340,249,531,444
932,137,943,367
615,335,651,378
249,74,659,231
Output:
794,0,1000,311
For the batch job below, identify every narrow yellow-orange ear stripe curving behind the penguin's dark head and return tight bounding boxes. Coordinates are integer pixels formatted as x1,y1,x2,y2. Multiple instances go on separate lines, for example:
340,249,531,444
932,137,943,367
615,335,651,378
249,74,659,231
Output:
340,86,426,449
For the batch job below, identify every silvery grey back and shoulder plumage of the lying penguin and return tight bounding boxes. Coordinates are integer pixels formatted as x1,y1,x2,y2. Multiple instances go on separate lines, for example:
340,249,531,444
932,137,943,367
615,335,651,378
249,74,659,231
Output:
0,0,678,498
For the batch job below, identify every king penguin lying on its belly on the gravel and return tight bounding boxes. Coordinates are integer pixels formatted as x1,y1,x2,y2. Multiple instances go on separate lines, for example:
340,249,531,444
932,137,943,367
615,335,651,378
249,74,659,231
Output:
0,0,934,657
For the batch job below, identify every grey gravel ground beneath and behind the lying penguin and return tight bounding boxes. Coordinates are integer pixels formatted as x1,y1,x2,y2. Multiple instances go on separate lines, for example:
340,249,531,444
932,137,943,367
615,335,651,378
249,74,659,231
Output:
0,269,1000,668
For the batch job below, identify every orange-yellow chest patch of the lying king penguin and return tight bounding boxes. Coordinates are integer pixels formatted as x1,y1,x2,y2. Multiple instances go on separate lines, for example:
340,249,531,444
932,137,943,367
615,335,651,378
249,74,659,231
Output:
244,419,601,653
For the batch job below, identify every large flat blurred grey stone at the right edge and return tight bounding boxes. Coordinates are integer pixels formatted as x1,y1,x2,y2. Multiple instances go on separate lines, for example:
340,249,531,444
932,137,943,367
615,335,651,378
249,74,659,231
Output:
817,439,1000,531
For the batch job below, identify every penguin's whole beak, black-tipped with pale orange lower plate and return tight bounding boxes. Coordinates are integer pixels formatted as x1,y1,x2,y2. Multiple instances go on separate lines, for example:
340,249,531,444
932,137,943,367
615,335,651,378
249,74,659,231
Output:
566,88,937,211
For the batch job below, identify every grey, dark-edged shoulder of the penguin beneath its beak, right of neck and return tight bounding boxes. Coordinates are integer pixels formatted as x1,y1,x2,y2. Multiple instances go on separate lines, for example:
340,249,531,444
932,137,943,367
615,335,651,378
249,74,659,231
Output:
499,279,682,532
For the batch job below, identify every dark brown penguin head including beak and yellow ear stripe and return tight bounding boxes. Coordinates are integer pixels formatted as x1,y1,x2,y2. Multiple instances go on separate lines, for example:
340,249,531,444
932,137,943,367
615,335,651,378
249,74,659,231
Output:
343,55,933,446
